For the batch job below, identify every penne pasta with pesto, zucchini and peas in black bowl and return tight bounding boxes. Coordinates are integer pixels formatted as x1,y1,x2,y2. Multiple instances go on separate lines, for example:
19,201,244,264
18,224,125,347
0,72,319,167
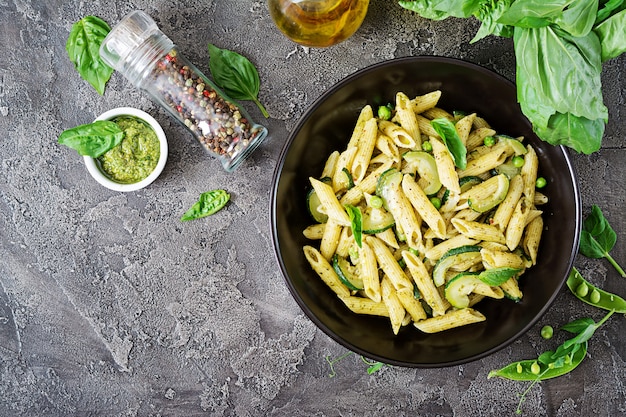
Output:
303,90,548,334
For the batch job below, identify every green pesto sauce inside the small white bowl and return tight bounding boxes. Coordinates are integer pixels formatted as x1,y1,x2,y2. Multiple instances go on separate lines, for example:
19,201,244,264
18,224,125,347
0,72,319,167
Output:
98,116,161,184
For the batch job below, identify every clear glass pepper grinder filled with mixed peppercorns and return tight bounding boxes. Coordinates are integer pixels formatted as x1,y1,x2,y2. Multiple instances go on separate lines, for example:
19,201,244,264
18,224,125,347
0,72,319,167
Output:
100,10,267,172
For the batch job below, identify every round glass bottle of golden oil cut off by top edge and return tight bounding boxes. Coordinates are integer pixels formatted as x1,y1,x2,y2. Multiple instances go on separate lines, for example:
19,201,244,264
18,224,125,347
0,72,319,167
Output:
267,0,369,47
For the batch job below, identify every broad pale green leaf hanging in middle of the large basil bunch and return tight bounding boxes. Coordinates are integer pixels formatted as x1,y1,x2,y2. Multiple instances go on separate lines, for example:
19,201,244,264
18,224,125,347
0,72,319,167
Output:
514,26,608,120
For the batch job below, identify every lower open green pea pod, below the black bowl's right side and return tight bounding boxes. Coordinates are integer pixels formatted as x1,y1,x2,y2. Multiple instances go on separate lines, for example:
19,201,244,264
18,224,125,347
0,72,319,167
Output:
487,342,587,381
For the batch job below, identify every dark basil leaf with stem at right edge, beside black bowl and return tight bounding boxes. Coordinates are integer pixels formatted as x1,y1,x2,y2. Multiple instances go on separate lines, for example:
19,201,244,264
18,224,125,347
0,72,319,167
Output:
580,205,626,278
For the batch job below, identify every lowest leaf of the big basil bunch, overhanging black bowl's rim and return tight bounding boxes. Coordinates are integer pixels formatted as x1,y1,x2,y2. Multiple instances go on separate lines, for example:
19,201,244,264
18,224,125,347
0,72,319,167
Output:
531,113,605,154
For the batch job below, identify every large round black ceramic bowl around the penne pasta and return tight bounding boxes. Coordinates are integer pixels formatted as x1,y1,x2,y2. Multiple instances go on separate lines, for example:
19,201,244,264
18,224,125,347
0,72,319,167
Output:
271,57,581,368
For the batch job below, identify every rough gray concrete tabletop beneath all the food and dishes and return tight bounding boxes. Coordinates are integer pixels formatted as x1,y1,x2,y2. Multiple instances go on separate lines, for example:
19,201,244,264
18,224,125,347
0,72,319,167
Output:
0,0,626,417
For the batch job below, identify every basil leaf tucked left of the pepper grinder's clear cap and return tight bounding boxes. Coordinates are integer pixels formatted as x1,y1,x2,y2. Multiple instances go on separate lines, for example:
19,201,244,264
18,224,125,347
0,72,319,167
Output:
65,16,113,95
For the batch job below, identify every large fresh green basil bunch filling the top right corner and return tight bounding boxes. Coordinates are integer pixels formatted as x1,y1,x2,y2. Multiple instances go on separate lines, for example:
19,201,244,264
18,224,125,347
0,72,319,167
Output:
399,0,626,154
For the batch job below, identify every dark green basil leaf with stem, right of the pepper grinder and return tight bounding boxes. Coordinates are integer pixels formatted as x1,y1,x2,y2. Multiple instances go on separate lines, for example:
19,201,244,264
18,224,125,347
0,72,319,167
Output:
209,44,269,117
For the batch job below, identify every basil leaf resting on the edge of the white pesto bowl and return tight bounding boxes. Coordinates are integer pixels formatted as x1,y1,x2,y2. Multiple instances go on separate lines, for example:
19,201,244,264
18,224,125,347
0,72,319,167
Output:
59,120,124,158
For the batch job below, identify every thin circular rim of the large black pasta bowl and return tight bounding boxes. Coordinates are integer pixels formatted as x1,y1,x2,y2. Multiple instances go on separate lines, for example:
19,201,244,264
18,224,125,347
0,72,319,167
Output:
269,55,582,369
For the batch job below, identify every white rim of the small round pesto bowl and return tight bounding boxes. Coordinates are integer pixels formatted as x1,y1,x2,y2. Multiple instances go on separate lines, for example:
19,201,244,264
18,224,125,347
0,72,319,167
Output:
84,107,169,192
